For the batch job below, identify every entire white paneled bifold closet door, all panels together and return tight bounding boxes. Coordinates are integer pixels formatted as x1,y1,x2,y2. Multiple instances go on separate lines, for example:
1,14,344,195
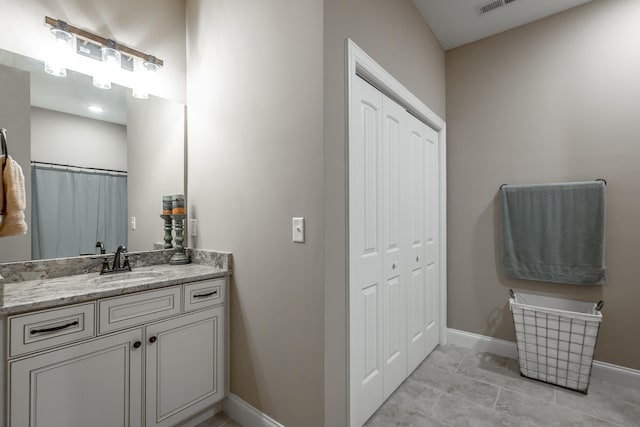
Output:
349,78,439,426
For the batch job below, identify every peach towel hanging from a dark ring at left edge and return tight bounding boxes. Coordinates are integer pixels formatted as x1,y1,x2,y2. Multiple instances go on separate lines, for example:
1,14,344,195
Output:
0,129,28,237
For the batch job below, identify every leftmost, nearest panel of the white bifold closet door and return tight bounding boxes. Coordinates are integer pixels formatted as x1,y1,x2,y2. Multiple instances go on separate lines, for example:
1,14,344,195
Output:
349,78,384,426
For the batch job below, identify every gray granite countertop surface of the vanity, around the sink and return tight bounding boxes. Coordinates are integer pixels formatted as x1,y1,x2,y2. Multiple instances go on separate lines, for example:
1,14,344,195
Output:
0,264,231,315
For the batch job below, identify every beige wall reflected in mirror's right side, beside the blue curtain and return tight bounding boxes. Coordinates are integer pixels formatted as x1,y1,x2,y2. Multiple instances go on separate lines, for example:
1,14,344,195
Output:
126,96,186,251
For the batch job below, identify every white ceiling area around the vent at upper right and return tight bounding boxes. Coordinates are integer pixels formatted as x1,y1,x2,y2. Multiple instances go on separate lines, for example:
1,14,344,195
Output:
413,0,591,50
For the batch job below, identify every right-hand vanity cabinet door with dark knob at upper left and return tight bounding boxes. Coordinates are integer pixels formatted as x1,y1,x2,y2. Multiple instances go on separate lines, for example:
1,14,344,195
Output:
145,307,224,427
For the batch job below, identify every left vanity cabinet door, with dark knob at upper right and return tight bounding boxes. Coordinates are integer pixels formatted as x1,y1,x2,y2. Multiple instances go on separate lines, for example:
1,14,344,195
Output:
9,329,142,427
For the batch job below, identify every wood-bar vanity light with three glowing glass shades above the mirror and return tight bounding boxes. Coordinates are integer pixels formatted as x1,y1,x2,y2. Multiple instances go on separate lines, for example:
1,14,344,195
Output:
44,16,164,99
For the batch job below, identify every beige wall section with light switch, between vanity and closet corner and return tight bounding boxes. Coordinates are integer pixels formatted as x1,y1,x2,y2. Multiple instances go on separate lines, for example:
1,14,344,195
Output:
187,0,323,427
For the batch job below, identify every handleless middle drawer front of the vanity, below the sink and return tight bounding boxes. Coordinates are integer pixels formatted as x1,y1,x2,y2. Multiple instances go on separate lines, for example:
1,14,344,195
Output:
98,286,181,334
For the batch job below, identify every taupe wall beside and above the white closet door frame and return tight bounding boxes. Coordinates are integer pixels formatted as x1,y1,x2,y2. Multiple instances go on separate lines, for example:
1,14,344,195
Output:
324,0,445,427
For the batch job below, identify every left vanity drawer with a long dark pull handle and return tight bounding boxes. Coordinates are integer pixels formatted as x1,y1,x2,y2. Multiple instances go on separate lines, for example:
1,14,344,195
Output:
9,303,95,357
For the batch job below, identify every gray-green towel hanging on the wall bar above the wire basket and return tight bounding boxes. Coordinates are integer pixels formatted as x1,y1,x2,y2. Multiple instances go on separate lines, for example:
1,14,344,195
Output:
500,181,607,285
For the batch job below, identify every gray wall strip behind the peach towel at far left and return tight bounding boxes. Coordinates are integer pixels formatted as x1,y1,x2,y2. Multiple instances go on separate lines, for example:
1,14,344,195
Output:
0,65,31,262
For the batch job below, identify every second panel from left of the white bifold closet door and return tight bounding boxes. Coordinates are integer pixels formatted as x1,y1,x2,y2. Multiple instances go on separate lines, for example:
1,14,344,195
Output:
382,96,409,399
